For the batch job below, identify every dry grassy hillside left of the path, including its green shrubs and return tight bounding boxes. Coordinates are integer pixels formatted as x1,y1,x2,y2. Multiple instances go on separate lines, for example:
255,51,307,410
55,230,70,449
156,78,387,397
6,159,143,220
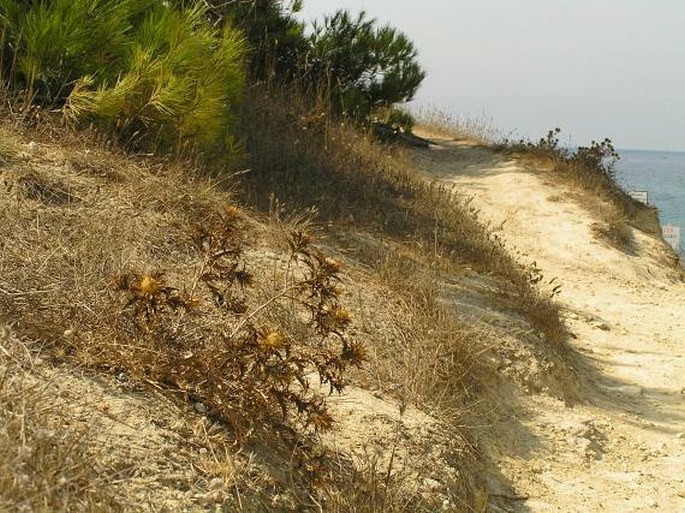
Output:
0,0,668,512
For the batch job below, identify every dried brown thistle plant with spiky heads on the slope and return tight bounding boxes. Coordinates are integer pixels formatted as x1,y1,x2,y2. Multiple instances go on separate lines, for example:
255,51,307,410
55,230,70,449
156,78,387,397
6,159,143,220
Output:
114,208,365,436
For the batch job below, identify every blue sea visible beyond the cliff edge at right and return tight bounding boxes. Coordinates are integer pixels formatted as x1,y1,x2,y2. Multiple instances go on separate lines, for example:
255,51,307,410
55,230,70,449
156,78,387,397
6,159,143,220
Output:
616,150,685,256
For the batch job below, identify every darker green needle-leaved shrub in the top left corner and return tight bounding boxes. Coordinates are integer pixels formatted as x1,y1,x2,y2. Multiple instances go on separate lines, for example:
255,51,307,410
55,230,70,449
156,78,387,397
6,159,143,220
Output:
0,0,151,103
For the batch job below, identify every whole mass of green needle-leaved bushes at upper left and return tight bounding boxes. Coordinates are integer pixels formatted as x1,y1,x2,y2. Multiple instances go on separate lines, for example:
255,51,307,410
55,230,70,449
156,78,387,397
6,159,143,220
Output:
0,0,246,155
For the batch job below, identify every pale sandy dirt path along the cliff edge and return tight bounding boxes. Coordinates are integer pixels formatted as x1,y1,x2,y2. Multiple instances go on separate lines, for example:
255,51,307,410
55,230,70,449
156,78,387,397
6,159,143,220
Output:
416,135,685,512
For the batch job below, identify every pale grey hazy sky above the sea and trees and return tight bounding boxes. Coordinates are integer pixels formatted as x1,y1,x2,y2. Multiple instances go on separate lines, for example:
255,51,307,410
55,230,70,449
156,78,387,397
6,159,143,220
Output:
302,0,685,150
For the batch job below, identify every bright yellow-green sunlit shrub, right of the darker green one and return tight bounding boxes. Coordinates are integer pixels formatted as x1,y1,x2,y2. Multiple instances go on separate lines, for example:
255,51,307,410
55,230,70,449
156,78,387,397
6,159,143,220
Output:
66,6,245,154
